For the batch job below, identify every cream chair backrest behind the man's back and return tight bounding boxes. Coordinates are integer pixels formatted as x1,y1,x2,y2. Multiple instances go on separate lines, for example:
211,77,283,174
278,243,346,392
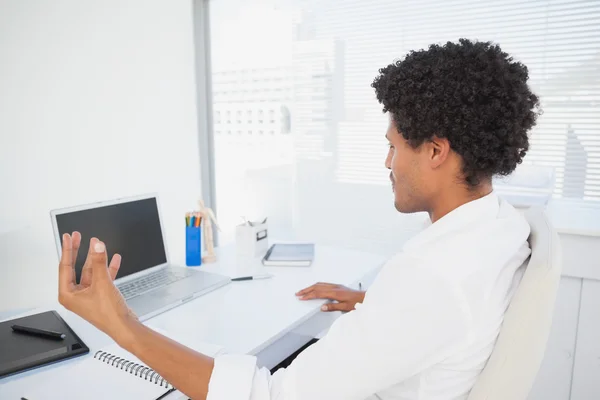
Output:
469,207,562,400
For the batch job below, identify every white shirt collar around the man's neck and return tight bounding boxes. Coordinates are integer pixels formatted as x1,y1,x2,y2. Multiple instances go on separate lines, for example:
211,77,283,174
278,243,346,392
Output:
403,191,500,252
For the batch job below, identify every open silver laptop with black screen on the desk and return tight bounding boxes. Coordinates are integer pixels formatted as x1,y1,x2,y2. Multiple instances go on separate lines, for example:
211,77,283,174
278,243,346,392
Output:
50,194,231,321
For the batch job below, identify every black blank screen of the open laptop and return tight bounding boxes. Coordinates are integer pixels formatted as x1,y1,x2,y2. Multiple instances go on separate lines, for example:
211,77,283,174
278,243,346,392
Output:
56,197,167,282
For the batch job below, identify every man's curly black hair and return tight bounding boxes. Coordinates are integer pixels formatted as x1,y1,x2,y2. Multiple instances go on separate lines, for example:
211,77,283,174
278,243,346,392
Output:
371,39,540,187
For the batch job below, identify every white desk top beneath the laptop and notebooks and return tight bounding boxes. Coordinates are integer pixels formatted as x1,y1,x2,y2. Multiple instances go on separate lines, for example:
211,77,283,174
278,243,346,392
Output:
0,246,385,400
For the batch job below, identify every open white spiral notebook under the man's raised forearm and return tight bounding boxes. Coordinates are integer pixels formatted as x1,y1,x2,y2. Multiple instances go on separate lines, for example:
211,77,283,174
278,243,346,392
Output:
23,336,224,400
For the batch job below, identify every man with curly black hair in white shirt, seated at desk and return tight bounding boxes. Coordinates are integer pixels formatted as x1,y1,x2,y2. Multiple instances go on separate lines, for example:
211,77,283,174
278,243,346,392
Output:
59,40,538,400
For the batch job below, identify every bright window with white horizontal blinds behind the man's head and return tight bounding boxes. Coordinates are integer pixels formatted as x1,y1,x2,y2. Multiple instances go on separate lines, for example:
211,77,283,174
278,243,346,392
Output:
210,0,600,250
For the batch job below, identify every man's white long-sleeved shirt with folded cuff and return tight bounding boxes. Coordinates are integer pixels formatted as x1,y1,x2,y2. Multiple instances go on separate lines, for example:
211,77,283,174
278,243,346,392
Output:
208,193,530,400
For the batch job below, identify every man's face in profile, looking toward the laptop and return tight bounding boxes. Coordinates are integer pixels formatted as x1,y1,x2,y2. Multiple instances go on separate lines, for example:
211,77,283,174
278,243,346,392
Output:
385,115,429,213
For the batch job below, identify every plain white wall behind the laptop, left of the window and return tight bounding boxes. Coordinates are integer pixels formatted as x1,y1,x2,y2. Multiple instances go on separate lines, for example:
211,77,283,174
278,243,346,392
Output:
0,0,200,310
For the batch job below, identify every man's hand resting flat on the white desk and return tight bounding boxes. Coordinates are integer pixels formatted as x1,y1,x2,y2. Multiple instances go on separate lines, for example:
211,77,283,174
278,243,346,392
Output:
296,282,365,311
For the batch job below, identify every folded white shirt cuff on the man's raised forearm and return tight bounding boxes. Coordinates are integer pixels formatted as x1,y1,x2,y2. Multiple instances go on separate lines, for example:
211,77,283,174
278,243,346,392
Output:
206,354,256,400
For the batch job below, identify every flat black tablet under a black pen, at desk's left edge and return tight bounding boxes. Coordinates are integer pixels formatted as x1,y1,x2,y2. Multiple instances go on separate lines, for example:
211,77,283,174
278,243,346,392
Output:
0,311,90,378
